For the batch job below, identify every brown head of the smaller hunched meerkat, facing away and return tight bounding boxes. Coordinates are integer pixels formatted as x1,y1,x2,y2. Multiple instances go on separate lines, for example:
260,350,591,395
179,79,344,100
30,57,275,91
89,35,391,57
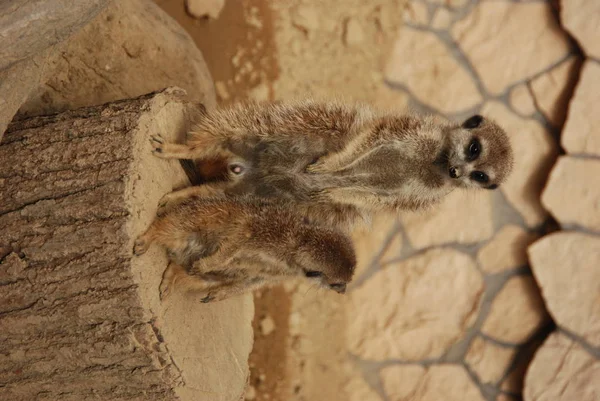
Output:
294,229,356,294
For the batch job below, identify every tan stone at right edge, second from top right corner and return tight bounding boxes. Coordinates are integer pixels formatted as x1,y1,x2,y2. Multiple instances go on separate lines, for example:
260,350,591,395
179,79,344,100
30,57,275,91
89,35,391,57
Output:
562,61,600,156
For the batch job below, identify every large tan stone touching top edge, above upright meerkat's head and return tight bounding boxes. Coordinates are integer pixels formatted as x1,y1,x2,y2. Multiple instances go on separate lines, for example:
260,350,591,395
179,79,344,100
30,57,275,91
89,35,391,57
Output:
451,1,570,97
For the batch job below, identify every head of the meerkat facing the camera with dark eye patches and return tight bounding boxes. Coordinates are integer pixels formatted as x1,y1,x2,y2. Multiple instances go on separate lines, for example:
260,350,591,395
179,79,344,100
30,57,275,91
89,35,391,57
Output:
444,115,513,189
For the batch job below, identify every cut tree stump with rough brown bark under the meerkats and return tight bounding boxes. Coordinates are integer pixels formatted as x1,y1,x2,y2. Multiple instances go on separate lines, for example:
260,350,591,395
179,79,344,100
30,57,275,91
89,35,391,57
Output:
0,90,253,401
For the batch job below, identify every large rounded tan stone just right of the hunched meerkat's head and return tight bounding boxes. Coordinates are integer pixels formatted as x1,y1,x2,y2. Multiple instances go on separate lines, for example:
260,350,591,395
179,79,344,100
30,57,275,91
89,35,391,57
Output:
347,249,483,361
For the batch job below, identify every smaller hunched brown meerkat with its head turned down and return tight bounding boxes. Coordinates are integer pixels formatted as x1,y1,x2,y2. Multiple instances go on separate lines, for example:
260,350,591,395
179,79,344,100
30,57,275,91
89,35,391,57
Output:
134,196,356,302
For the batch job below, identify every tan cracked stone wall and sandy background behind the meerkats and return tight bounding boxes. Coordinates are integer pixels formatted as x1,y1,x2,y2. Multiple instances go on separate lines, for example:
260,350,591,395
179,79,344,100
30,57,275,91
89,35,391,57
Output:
154,0,600,401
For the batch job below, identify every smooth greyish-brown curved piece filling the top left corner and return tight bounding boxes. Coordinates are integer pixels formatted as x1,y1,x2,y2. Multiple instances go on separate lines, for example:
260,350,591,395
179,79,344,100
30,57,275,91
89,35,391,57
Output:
0,0,108,71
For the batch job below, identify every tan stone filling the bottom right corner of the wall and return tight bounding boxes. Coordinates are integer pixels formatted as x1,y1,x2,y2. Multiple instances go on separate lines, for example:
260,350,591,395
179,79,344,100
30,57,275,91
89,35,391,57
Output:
524,333,600,401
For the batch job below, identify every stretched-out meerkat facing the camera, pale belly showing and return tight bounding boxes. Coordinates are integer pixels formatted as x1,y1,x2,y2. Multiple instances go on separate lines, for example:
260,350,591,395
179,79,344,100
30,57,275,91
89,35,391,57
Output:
151,101,513,225
